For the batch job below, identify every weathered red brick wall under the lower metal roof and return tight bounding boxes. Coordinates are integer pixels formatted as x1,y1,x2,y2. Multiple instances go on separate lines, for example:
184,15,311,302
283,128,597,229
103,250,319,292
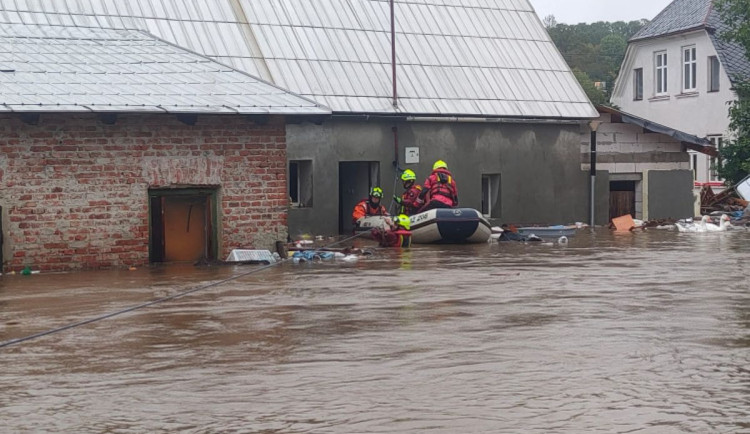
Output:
0,114,287,271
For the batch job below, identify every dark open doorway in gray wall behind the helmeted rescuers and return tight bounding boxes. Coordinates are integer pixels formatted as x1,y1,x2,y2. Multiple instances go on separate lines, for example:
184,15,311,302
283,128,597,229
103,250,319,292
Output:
339,161,388,234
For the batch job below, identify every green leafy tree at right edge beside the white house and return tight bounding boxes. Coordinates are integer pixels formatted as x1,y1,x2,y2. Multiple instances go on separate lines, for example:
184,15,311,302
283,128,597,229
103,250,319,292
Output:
716,0,750,184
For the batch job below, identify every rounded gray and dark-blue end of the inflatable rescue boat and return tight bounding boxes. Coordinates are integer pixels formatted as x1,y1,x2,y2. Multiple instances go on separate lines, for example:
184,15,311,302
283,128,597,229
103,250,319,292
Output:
409,208,492,244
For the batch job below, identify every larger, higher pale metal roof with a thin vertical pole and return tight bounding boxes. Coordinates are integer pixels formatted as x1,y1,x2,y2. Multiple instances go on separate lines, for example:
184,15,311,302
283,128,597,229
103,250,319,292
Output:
0,0,598,118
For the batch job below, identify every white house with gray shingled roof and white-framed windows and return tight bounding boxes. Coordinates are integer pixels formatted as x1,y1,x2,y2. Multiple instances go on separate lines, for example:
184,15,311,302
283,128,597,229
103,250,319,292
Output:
612,0,750,185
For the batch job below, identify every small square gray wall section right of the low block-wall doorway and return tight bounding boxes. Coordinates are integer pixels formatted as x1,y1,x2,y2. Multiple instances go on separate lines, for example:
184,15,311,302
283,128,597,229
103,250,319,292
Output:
648,170,695,219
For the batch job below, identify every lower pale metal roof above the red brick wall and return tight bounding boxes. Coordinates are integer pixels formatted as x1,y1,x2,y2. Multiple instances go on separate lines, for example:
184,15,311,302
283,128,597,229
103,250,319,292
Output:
0,24,330,114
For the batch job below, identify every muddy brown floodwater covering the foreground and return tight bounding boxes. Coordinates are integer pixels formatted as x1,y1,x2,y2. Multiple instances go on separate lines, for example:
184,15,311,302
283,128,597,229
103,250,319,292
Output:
0,230,750,433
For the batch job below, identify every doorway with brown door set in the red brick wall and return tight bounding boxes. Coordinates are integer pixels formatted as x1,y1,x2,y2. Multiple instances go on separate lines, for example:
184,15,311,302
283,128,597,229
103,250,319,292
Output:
149,189,217,262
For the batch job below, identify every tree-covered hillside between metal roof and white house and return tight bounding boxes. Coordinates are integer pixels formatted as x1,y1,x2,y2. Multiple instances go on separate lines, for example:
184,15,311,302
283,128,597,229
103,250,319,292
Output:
545,20,646,105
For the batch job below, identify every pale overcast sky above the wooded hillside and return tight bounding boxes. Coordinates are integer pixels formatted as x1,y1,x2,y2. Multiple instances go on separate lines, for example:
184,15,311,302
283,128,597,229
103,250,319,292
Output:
530,0,672,24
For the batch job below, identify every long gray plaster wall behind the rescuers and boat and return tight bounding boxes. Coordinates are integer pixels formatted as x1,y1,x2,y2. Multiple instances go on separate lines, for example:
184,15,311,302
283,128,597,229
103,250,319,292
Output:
287,119,609,238
